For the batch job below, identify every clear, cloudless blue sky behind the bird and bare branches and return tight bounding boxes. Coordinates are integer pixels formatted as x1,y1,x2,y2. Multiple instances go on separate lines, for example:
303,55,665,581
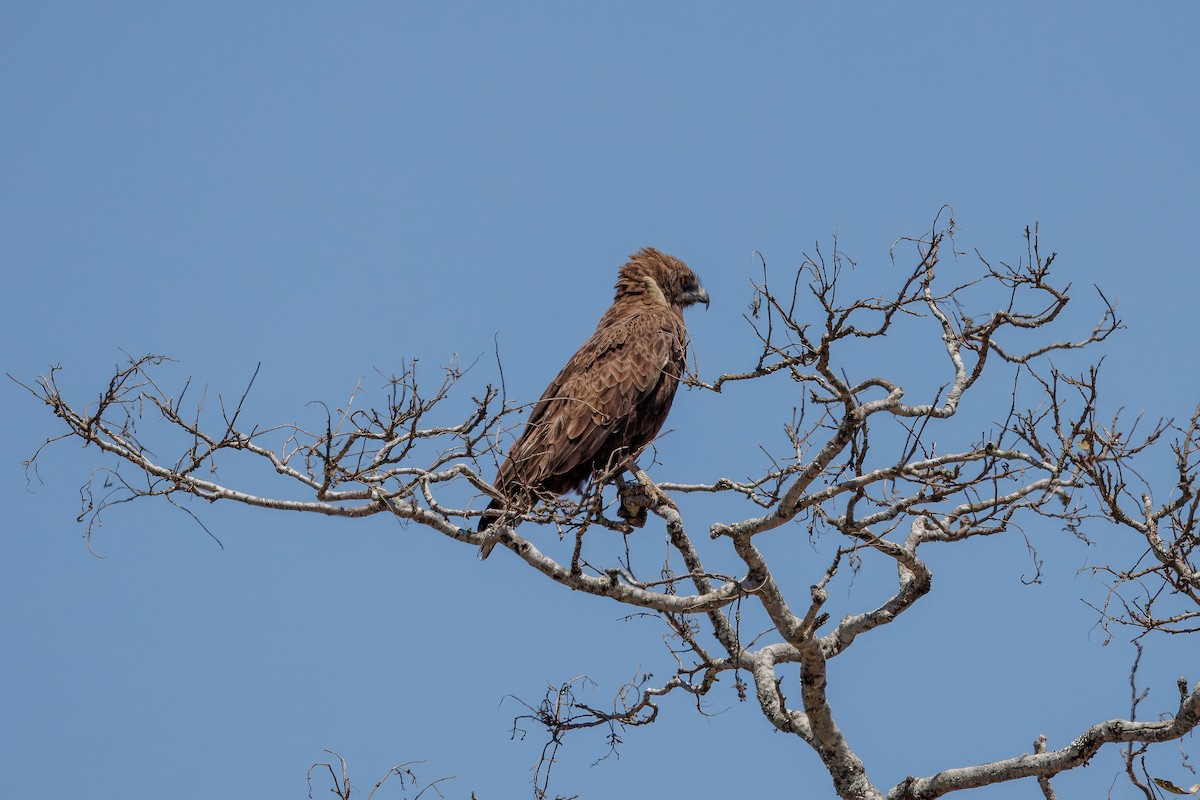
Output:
0,2,1200,800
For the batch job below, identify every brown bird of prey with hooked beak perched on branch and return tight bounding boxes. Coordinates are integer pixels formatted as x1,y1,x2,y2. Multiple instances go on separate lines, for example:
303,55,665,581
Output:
479,247,708,558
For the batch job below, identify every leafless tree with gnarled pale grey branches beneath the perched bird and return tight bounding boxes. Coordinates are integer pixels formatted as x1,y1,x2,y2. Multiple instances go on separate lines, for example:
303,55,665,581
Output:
14,212,1200,800
